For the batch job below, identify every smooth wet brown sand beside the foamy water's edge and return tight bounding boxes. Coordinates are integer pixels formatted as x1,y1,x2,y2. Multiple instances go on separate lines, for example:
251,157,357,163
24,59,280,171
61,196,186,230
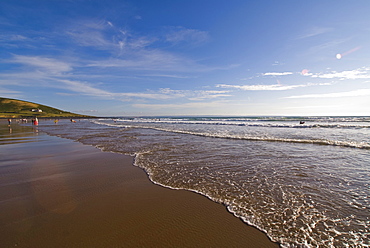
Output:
0,120,278,247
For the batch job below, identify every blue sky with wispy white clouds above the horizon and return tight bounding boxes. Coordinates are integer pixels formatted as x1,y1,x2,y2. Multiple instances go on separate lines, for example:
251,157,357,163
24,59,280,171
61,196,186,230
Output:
0,0,370,116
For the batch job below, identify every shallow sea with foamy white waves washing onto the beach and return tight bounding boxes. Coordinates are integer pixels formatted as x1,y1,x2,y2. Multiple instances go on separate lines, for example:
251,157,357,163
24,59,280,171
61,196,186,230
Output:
38,116,370,247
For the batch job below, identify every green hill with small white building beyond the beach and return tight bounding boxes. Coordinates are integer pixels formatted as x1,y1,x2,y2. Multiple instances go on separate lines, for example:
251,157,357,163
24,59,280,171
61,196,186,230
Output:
0,97,93,118
